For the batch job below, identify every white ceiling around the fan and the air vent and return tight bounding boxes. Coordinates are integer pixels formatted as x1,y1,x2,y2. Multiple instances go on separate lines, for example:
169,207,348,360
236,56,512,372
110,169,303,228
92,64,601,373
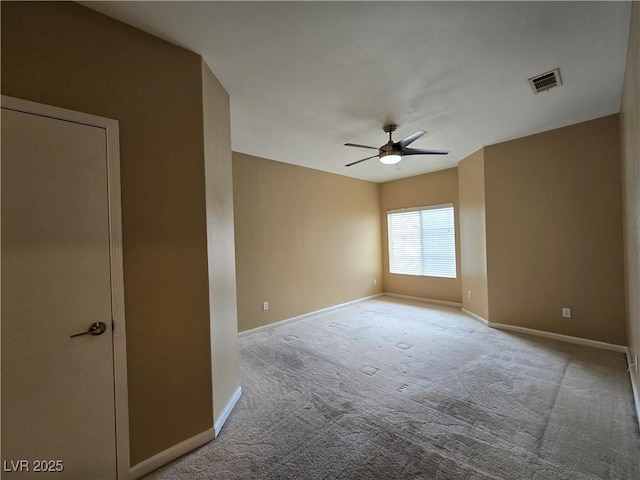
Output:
80,1,630,182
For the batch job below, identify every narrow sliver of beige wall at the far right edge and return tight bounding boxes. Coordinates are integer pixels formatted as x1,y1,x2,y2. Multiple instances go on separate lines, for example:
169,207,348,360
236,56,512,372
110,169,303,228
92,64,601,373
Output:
620,2,640,394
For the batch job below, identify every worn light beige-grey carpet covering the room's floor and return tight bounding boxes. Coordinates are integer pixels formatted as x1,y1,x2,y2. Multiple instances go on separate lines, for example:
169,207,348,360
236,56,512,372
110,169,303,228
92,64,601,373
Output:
146,297,640,480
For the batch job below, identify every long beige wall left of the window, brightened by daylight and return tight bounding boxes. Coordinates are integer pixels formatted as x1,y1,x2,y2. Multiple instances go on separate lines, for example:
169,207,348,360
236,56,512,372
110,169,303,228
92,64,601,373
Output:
233,152,382,331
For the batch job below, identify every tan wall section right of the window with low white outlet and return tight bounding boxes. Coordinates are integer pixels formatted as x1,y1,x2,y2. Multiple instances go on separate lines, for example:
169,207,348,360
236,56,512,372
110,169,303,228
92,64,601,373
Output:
484,115,626,345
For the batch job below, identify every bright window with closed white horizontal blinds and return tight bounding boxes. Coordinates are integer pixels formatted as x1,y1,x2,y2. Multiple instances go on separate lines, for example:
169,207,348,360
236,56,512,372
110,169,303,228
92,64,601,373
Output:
387,204,456,278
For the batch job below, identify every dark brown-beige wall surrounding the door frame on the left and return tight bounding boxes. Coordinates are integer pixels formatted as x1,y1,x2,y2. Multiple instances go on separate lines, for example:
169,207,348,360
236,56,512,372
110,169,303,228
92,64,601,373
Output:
1,2,226,464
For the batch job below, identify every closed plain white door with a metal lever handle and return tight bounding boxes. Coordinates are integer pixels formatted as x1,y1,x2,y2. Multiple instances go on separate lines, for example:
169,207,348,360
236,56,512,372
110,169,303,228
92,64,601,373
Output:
1,104,116,480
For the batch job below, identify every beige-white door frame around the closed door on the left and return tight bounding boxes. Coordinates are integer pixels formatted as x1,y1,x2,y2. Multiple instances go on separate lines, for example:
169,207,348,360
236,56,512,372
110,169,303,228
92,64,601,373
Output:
1,95,130,480
